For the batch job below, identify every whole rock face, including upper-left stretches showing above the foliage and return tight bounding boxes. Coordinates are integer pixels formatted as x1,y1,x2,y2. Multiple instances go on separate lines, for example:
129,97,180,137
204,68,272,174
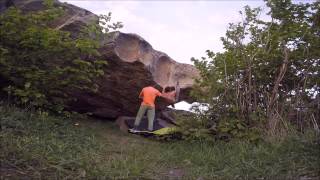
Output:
0,0,198,119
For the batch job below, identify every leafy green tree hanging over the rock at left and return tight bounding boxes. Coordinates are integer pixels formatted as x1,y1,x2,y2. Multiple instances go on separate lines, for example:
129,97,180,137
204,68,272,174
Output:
0,0,122,112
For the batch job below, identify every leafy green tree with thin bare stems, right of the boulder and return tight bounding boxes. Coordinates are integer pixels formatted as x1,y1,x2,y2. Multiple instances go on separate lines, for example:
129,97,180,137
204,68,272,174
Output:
192,0,320,139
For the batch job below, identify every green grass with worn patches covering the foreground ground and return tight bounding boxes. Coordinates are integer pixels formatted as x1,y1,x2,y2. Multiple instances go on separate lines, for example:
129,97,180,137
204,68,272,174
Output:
0,106,320,179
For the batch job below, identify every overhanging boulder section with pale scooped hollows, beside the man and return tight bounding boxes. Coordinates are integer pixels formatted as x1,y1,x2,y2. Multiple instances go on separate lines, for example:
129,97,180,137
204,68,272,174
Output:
73,32,197,118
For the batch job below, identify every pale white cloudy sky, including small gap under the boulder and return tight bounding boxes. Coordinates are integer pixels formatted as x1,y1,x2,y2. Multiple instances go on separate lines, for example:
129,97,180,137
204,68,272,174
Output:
60,0,310,110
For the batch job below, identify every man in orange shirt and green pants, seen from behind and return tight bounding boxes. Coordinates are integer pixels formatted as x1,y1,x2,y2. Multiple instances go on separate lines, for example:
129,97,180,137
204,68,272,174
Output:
131,86,175,132
